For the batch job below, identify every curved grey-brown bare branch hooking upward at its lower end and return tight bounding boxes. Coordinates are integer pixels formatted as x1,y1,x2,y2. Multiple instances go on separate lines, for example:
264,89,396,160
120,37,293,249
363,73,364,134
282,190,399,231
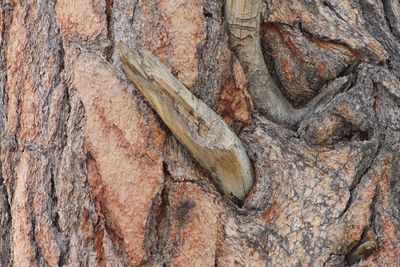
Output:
225,0,342,126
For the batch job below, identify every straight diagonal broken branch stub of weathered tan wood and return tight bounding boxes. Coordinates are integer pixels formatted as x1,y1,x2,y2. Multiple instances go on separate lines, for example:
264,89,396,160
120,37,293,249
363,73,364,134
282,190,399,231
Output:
118,43,254,200
